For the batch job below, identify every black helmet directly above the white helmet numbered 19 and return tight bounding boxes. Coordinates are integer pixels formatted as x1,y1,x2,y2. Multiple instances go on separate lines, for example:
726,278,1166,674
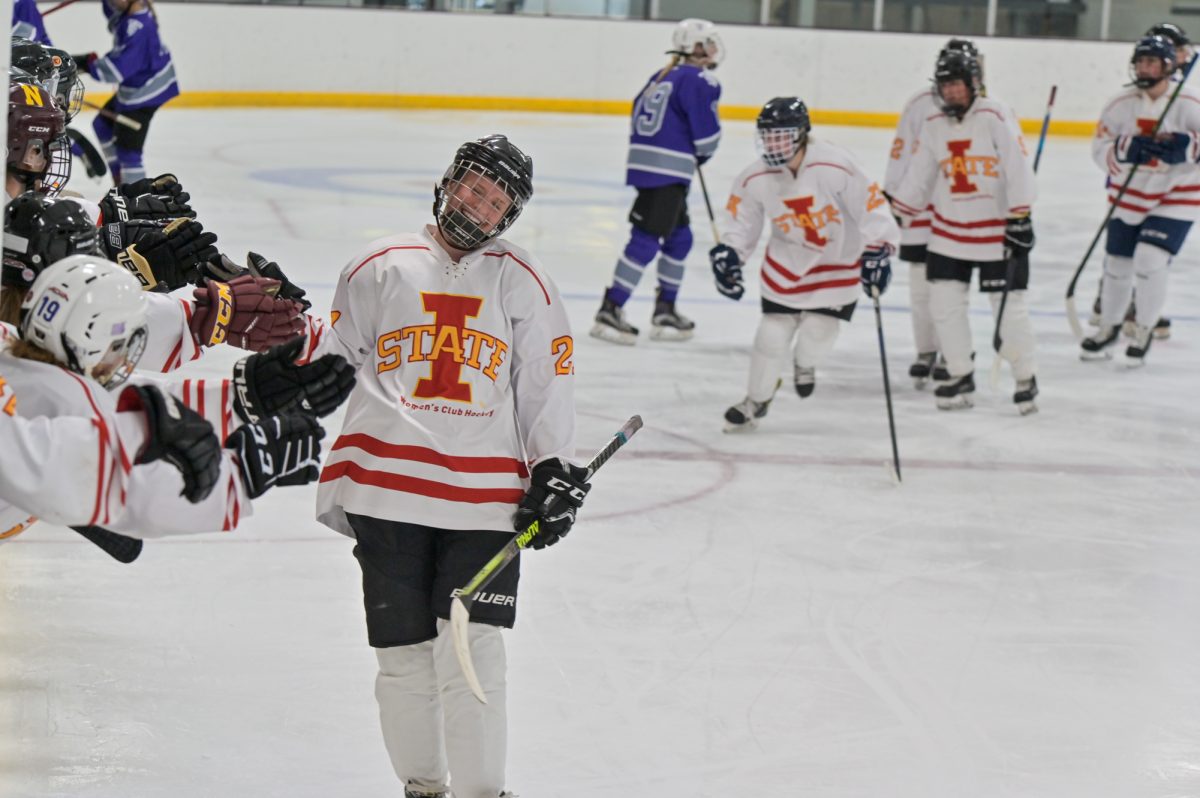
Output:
0,191,100,289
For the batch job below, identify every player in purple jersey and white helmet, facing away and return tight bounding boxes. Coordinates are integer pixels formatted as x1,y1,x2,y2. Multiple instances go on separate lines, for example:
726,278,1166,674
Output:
592,19,725,346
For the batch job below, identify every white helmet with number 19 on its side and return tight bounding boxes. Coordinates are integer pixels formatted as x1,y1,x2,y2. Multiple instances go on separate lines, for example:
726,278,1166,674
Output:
20,254,146,389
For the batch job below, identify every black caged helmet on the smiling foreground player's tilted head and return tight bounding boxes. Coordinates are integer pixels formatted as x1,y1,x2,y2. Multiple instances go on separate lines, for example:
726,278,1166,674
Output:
433,133,533,252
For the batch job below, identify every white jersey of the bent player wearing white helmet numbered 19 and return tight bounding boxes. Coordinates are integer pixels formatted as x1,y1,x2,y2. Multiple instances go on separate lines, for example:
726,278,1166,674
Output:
0,352,251,538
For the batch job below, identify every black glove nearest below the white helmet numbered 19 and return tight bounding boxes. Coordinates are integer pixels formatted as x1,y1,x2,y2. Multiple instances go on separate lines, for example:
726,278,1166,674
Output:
116,385,221,503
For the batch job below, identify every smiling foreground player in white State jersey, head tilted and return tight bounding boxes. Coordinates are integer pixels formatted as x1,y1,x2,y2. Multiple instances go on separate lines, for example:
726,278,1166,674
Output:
300,136,588,798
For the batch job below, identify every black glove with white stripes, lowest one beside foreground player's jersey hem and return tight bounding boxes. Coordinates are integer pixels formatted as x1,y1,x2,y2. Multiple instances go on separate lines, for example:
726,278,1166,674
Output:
226,413,325,499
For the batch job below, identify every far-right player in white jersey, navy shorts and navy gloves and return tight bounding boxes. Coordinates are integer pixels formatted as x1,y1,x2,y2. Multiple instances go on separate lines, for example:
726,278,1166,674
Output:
1080,35,1200,366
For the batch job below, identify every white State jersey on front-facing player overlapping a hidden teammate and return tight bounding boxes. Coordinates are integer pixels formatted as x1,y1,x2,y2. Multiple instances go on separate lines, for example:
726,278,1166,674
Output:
892,97,1037,263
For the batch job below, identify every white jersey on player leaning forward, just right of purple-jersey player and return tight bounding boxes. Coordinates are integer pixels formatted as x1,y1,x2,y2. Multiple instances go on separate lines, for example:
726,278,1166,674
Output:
721,139,900,310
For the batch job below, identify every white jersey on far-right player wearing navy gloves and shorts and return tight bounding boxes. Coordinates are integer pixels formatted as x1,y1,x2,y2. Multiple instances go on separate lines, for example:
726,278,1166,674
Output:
1092,86,1200,224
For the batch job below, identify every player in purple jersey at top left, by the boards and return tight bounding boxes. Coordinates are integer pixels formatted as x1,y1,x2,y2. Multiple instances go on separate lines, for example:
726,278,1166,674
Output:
73,0,179,185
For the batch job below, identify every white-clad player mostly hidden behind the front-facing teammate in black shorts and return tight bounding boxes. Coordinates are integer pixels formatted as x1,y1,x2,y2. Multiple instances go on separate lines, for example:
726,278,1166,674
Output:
883,38,983,388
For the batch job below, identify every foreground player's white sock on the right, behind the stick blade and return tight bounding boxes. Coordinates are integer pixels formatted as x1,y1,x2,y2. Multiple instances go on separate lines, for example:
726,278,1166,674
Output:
433,620,508,798
